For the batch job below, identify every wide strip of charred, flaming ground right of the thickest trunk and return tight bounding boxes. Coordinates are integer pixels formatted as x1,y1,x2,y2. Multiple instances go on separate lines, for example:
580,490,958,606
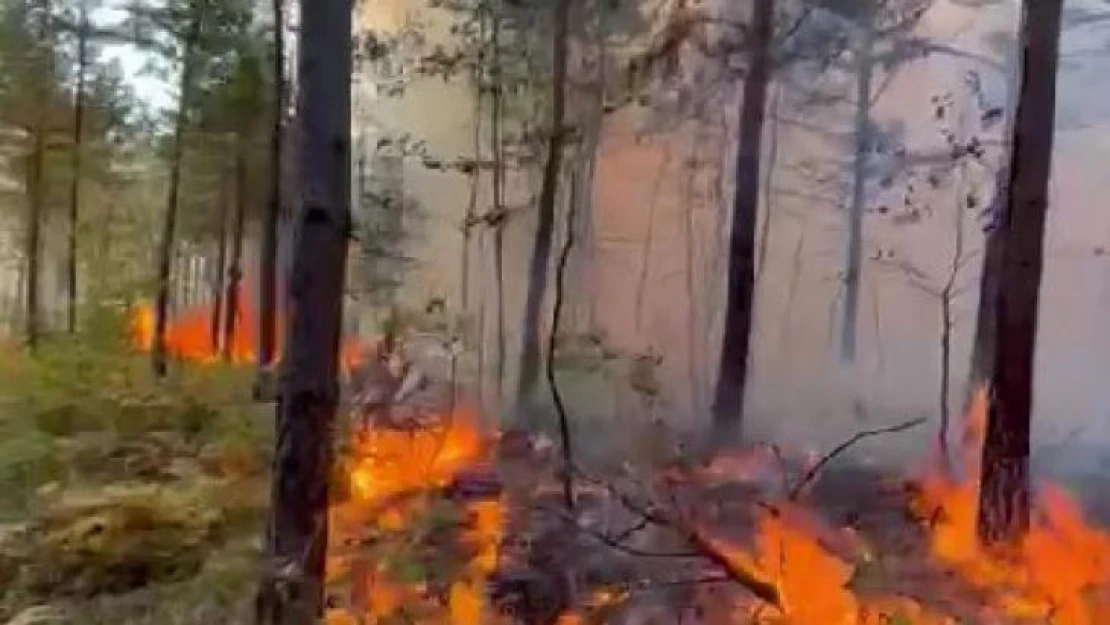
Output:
319,386,1110,625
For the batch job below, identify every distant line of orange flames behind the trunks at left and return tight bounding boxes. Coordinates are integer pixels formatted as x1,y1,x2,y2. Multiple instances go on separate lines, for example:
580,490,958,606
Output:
130,288,366,371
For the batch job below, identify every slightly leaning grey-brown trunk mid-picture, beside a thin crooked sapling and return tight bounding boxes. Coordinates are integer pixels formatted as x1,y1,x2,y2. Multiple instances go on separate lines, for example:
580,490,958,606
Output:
516,0,571,405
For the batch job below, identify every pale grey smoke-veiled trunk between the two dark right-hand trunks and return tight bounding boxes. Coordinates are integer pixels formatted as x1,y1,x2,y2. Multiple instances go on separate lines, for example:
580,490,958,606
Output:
840,7,875,362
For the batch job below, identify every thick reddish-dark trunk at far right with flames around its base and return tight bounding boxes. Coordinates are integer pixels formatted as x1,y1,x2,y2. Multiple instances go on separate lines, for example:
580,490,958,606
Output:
978,0,1063,543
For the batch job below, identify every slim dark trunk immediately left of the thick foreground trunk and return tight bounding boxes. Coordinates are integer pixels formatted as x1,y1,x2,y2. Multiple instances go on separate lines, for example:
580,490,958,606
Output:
259,0,285,370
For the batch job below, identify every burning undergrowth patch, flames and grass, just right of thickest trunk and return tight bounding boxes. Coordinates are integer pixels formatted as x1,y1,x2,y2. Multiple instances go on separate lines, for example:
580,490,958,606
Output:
327,414,504,625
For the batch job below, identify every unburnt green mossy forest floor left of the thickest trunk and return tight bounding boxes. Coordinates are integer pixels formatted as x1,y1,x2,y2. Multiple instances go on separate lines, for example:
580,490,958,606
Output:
0,342,272,625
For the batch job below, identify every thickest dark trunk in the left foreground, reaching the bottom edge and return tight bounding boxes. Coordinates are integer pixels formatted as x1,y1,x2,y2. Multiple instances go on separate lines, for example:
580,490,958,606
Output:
259,0,352,625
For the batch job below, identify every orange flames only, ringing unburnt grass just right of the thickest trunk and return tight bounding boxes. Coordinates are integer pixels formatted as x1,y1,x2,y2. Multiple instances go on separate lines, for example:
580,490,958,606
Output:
327,414,504,625
